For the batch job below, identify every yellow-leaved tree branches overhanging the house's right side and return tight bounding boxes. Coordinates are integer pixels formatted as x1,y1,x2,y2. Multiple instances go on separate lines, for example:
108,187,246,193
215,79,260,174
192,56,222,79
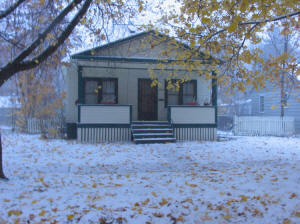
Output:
154,0,300,91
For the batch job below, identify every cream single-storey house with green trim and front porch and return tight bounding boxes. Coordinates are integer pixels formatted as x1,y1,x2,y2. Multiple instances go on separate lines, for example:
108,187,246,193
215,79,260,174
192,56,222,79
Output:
65,31,217,143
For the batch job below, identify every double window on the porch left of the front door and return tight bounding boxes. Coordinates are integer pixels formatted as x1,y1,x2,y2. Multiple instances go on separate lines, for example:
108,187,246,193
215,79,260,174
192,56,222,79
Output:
84,78,118,104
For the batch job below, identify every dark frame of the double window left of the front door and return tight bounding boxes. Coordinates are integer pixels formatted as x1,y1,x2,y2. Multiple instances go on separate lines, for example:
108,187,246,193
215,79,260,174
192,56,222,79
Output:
83,77,118,104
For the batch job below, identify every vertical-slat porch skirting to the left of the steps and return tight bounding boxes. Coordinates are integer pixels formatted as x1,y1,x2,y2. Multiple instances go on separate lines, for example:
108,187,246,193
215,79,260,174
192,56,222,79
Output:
77,127,131,143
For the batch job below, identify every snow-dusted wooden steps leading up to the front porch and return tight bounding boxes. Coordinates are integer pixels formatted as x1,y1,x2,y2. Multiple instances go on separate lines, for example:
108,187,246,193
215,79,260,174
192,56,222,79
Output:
131,121,176,144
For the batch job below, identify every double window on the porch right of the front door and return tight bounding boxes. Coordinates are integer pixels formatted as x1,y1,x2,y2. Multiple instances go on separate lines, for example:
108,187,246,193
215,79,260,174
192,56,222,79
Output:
165,79,197,107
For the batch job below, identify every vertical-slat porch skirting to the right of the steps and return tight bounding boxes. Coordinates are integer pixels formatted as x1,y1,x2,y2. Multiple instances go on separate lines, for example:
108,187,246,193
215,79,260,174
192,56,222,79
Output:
174,127,217,141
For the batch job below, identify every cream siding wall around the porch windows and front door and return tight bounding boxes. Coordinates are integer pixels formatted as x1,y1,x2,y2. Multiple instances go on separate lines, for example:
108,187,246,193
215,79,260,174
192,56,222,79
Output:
67,60,211,122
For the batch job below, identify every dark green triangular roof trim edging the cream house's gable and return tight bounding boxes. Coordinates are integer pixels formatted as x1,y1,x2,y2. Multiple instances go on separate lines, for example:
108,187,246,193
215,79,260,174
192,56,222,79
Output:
71,30,220,64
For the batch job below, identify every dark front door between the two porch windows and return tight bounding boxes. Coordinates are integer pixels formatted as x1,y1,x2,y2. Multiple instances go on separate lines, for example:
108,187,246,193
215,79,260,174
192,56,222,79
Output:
138,79,157,121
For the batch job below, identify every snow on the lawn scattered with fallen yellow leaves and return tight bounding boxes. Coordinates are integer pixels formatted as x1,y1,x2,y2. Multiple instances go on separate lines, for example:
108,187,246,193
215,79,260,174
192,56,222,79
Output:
0,134,300,223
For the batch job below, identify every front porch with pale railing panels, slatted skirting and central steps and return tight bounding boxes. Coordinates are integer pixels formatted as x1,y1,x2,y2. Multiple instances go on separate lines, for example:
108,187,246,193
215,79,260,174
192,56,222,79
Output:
77,104,217,143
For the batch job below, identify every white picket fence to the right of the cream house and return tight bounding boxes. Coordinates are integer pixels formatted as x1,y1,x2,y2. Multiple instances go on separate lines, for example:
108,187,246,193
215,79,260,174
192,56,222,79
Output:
233,116,295,136
